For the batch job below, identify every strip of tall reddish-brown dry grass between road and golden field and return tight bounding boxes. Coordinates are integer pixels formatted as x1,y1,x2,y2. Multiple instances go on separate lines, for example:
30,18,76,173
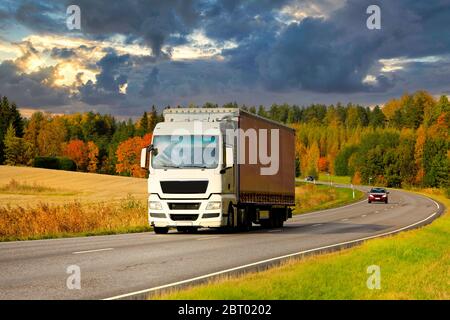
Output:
0,196,150,241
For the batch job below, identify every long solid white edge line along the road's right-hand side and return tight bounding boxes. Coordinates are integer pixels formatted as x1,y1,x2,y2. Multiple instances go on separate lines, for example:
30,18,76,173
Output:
104,198,440,300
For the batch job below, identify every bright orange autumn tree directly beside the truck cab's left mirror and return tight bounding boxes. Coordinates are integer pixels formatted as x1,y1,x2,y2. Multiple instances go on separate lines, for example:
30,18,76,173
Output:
116,133,152,178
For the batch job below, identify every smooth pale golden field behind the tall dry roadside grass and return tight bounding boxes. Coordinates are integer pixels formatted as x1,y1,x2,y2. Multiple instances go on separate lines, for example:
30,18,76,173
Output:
0,166,147,206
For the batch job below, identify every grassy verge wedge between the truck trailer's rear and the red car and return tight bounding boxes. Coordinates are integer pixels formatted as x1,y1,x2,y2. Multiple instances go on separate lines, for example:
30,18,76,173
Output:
293,183,364,214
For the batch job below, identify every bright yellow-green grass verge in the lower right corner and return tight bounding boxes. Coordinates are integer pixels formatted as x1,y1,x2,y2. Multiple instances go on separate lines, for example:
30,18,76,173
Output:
156,190,450,300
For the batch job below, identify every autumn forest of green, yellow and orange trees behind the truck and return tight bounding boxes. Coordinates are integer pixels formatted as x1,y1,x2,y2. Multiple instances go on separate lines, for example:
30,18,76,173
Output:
0,91,450,187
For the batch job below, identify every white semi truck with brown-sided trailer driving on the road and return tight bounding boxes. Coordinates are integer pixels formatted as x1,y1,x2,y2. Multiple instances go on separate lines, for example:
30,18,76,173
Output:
141,108,295,233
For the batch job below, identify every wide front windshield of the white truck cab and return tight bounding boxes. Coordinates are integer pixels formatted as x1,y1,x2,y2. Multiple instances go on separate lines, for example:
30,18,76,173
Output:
152,135,219,169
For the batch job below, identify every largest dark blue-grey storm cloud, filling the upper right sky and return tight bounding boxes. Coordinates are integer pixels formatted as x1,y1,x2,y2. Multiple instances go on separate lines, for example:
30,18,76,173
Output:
226,0,450,93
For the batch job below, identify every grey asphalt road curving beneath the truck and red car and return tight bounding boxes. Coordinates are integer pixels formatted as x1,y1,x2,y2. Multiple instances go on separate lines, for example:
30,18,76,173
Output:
0,191,438,299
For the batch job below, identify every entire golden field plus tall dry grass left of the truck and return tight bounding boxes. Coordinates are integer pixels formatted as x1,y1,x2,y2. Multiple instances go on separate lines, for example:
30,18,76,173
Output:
0,166,150,241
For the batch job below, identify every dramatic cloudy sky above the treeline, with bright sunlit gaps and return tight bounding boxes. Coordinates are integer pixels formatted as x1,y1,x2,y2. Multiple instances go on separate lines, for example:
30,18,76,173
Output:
0,0,450,117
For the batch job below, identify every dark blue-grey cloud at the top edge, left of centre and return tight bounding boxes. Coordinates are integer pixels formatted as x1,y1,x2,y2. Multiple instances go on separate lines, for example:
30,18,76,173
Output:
70,0,199,55
